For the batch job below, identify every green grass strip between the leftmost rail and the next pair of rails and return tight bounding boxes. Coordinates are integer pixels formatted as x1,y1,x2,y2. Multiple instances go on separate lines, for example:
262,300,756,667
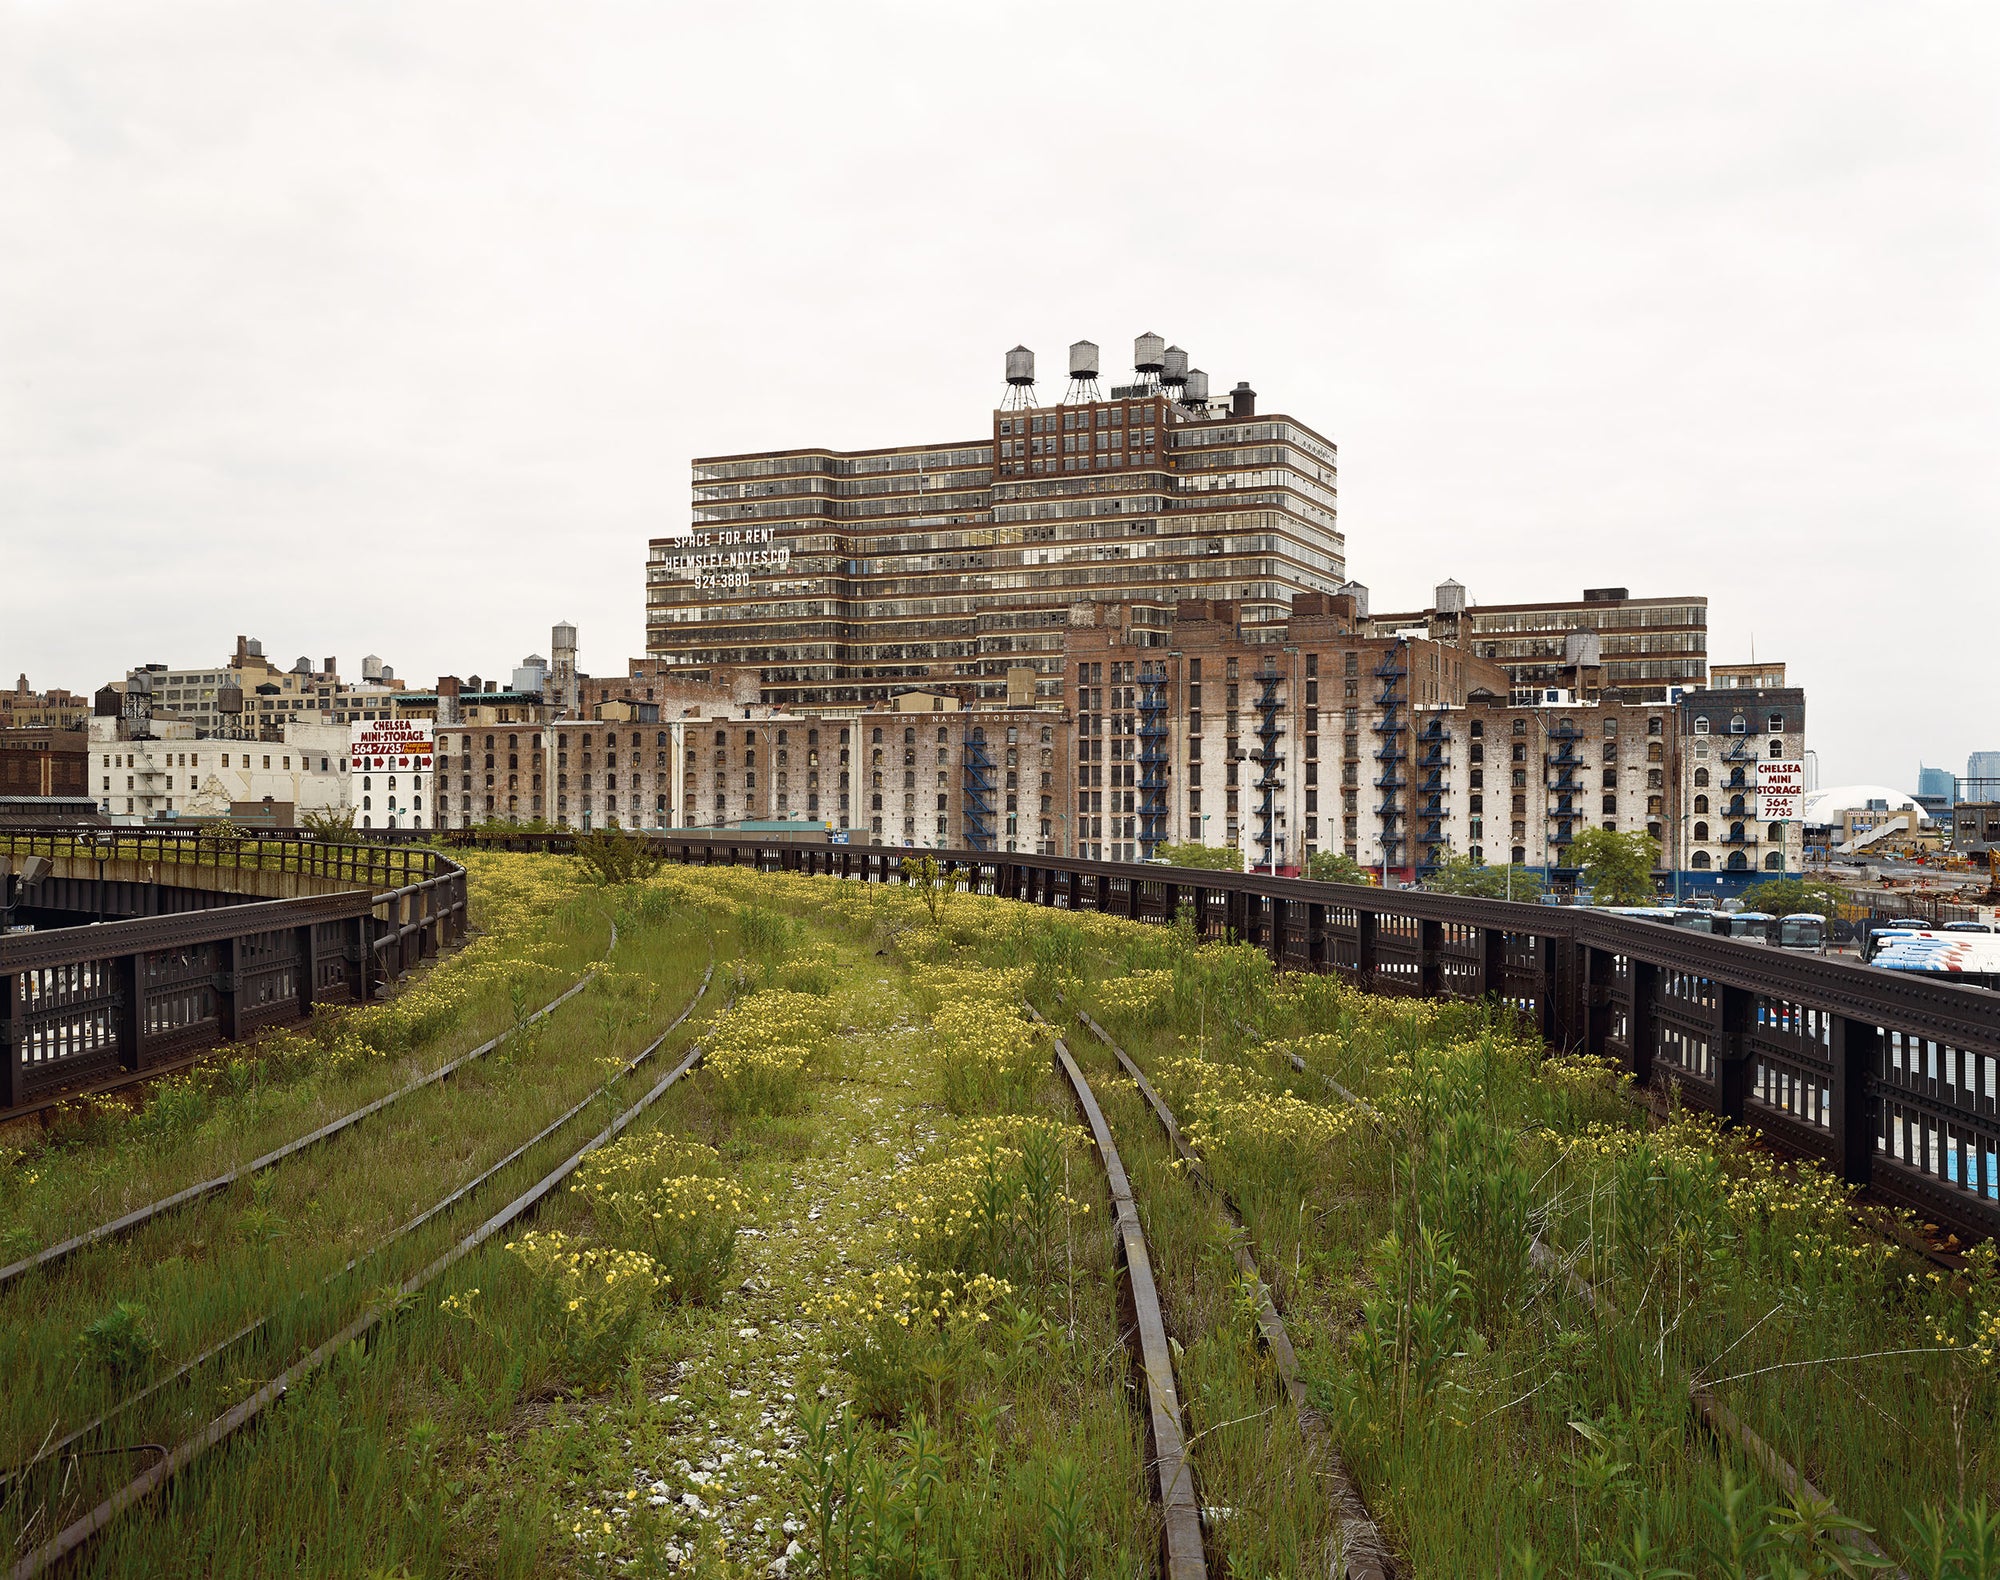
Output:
0,860,728,1568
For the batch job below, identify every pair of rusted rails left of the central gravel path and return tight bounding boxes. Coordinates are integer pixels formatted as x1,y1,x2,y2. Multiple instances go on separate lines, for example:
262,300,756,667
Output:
6,956,714,1580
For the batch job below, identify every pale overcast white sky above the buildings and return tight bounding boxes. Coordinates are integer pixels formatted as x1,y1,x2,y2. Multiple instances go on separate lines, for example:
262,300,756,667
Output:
0,0,2000,788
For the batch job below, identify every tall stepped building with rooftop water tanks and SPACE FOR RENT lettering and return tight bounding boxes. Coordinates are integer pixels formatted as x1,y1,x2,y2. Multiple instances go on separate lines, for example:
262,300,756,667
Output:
646,334,1346,708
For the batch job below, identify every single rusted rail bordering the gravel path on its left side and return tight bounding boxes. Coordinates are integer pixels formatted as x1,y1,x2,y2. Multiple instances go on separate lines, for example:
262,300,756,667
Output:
8,984,728,1580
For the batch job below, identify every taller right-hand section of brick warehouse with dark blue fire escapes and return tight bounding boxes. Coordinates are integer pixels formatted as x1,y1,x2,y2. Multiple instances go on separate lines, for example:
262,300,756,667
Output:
1058,594,1804,882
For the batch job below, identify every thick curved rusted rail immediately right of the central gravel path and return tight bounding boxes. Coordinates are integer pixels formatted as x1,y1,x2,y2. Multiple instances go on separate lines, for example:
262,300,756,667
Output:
1028,1004,1208,1580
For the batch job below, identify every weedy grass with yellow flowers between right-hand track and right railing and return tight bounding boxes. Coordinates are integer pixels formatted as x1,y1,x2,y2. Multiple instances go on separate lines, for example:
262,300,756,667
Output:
1096,908,2000,1576
